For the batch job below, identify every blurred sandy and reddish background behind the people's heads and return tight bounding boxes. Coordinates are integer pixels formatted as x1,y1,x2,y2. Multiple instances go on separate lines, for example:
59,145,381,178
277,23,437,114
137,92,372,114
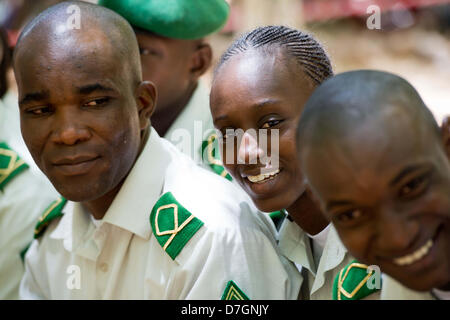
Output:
0,0,450,123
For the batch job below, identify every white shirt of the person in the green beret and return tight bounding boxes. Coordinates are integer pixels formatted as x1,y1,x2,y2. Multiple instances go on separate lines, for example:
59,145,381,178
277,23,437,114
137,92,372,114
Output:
164,81,215,170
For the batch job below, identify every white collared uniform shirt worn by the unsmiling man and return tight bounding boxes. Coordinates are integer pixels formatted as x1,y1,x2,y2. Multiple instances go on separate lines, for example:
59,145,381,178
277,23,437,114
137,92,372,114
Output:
20,129,300,299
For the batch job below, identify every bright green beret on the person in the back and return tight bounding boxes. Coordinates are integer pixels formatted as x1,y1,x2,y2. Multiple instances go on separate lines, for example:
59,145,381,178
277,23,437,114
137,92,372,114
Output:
98,0,230,40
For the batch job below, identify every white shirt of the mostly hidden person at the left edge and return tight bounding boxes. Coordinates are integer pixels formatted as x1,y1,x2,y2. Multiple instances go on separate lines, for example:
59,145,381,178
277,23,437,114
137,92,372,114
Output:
0,165,58,300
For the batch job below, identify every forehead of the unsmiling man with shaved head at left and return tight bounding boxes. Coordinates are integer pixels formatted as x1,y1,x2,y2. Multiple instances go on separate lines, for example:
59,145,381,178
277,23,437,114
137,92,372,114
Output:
14,28,126,91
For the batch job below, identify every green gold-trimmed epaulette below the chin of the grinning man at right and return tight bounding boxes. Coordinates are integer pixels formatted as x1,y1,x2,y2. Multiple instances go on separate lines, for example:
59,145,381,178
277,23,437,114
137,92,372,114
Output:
333,260,380,300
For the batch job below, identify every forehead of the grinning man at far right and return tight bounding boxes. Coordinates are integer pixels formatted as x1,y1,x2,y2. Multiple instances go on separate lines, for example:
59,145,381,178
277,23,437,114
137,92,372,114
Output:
302,108,448,196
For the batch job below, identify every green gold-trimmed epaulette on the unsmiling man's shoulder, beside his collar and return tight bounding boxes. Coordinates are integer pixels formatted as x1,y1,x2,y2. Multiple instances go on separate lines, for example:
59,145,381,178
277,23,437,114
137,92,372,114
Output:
150,192,203,260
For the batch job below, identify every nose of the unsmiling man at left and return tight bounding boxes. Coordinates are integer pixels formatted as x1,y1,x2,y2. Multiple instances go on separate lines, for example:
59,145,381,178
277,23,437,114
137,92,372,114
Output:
52,110,91,145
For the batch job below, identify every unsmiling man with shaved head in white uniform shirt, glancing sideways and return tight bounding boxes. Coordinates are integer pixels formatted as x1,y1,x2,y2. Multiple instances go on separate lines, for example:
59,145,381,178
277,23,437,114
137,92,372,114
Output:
14,2,299,299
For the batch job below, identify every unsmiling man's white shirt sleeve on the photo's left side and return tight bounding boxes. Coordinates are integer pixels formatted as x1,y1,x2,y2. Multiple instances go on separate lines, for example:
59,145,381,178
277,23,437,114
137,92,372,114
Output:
19,240,48,300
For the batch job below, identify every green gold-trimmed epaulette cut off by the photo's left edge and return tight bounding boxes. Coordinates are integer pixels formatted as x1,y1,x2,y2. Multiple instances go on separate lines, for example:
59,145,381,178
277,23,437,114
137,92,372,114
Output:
0,142,28,190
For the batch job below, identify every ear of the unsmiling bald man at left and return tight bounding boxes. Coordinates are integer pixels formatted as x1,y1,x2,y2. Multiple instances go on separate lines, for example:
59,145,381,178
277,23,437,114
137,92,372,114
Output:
136,81,157,130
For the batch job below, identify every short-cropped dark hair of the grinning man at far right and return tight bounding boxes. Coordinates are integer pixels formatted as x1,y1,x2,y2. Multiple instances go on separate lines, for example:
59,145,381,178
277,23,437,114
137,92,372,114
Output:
297,70,441,155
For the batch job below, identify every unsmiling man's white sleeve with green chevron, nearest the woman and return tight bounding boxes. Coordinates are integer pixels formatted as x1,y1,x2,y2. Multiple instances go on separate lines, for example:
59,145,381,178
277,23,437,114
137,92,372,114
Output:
163,222,301,300
